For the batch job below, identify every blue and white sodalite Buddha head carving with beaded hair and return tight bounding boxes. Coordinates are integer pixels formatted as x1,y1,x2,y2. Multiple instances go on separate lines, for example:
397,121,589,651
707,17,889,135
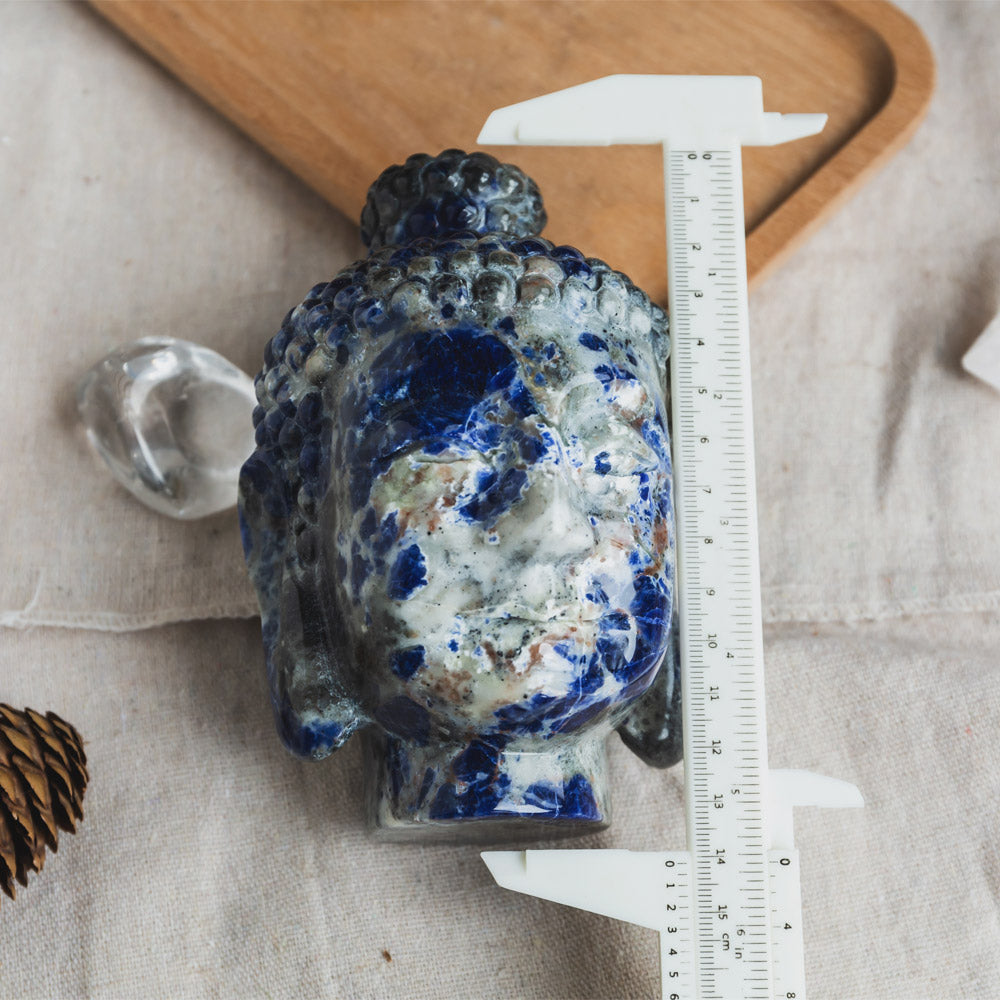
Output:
240,150,680,839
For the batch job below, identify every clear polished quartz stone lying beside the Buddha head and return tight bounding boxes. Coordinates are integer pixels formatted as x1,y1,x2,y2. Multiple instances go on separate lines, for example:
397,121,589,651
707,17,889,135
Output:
77,337,257,520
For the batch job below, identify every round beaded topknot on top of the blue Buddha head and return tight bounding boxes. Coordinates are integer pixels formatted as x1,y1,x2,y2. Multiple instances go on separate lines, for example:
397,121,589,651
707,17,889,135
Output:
361,149,546,251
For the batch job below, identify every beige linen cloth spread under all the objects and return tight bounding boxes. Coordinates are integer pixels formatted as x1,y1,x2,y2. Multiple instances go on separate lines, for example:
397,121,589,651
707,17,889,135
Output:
0,2,1000,1000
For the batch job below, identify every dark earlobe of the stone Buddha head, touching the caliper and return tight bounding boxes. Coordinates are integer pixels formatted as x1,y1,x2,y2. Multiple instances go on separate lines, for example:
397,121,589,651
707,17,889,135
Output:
618,605,684,767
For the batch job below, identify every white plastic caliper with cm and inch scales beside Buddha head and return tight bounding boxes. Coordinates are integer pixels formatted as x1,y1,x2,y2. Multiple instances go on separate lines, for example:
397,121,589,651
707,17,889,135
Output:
479,76,863,1000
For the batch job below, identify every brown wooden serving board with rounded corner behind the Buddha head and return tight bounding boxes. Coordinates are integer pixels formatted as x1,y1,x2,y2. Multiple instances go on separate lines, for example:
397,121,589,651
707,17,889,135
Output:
93,0,934,301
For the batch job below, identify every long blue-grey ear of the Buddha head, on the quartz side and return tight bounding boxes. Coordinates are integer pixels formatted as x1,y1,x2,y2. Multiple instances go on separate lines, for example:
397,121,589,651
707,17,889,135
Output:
240,482,368,760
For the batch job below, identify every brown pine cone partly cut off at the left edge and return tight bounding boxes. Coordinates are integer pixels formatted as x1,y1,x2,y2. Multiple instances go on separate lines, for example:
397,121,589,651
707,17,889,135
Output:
0,704,89,899
